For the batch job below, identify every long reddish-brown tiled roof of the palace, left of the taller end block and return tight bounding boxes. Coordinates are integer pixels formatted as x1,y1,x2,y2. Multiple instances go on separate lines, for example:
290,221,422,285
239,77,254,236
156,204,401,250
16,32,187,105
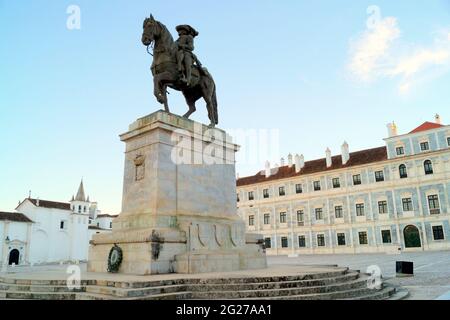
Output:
237,147,388,187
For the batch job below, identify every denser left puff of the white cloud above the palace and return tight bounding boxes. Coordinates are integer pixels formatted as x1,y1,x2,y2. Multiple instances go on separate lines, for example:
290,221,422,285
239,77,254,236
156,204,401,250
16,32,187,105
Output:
349,17,400,81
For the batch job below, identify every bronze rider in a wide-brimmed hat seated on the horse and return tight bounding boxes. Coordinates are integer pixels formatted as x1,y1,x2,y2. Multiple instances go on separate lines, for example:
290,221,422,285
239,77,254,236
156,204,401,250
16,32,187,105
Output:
176,25,202,86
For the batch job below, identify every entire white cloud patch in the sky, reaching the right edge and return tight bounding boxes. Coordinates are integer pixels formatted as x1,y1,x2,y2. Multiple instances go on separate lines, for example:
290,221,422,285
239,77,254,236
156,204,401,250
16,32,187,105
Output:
349,17,450,95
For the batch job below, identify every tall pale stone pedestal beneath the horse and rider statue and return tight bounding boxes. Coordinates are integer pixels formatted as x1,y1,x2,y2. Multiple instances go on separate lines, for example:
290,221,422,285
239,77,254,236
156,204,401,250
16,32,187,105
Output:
88,111,267,275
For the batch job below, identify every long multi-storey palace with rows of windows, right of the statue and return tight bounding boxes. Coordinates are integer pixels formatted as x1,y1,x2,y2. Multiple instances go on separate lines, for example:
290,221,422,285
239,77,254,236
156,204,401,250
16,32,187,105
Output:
237,115,450,256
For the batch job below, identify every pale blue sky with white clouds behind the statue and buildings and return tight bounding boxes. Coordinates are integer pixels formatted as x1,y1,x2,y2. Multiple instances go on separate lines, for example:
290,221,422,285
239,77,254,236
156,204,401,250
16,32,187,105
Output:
0,0,450,213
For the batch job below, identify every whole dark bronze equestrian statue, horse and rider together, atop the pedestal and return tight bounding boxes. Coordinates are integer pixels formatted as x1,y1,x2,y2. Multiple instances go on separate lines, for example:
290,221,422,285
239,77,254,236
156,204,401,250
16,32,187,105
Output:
142,15,219,127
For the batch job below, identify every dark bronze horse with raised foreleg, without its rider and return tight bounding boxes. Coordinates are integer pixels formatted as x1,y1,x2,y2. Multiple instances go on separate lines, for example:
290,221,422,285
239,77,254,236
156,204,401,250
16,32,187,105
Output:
142,16,219,127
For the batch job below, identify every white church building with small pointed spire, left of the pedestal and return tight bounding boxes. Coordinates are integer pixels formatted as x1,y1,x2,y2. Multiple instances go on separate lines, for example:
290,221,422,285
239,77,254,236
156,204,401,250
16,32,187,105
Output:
0,181,118,264
